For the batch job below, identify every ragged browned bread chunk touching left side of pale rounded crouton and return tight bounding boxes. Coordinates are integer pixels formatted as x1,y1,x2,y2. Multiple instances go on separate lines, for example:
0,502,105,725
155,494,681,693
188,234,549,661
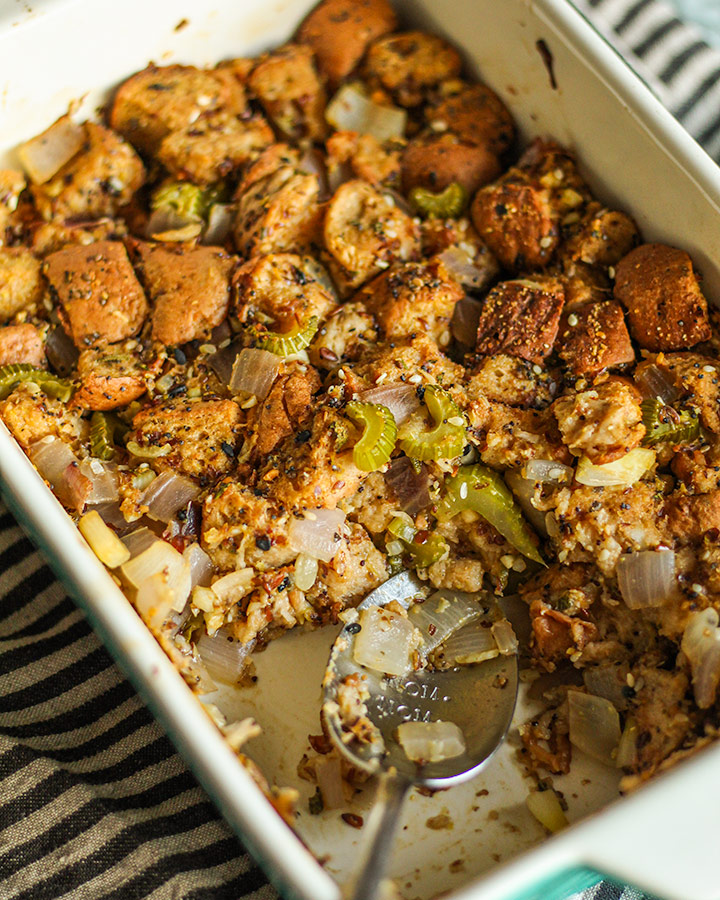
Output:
470,402,572,470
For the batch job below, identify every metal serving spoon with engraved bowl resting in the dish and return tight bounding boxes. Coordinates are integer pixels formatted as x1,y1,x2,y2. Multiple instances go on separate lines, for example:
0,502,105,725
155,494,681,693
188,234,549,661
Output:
323,572,518,900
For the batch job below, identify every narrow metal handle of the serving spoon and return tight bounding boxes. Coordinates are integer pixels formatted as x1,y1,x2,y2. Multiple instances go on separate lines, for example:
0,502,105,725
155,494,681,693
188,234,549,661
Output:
343,771,410,900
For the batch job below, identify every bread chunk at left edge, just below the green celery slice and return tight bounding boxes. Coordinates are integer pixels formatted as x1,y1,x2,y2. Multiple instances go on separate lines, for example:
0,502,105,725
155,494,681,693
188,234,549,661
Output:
0,382,89,450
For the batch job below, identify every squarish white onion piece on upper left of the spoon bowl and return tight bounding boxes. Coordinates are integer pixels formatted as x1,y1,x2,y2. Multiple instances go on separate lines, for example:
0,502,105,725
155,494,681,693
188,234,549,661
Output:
353,606,417,675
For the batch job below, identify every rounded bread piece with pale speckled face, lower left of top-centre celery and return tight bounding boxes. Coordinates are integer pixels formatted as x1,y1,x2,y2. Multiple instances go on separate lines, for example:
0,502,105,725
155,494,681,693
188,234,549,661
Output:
324,180,420,296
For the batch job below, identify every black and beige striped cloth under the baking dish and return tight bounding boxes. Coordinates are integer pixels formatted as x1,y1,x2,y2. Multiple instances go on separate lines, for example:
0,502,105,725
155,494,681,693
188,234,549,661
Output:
0,0,720,900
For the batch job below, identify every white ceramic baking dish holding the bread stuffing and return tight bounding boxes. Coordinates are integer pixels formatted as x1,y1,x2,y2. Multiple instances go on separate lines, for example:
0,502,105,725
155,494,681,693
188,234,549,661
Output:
0,0,720,900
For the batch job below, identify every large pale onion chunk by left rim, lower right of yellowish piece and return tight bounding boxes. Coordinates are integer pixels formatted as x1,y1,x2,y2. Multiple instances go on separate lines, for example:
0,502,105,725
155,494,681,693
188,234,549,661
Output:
120,541,191,618
